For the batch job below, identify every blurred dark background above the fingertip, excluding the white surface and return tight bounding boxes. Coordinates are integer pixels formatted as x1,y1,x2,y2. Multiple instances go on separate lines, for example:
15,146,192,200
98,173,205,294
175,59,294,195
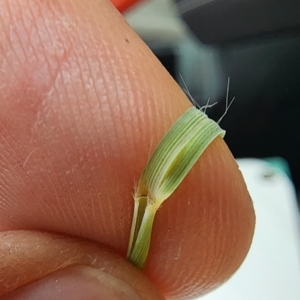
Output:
112,0,300,202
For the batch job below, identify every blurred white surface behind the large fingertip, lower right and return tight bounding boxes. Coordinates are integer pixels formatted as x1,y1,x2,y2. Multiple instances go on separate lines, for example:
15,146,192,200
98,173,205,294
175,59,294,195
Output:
199,159,300,300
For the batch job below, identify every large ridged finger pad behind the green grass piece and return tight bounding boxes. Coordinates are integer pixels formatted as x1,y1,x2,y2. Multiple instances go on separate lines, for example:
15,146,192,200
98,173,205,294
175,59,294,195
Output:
0,0,255,299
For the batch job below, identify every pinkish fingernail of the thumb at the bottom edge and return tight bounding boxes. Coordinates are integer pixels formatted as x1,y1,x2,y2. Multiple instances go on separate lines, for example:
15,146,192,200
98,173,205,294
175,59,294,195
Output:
1,266,141,300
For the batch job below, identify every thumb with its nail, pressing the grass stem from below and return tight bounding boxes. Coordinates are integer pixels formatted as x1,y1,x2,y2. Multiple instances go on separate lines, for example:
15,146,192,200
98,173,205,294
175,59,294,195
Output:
0,230,163,300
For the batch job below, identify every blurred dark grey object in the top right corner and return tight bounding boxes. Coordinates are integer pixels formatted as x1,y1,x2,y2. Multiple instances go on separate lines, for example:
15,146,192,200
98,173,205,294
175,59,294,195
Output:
175,0,300,44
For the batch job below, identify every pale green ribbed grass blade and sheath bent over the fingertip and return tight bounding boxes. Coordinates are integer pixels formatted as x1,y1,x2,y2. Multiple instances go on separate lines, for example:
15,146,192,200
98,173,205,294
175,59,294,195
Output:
127,107,225,268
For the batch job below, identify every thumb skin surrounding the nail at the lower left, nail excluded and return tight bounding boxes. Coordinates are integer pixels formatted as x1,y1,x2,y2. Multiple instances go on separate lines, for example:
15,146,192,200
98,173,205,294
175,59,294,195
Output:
0,230,164,300
